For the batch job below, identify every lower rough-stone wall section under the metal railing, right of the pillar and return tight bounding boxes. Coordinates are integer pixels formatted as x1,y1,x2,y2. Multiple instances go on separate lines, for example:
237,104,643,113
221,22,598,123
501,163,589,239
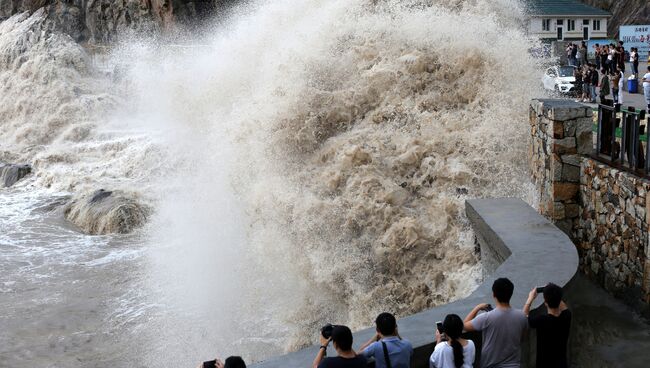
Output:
573,158,650,309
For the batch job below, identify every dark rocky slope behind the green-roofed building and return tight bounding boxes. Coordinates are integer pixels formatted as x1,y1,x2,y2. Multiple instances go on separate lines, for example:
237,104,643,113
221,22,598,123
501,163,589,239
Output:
583,0,650,36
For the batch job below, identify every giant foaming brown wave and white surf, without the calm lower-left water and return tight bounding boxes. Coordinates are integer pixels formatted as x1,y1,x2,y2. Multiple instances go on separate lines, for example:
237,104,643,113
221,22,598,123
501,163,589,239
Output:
0,0,539,354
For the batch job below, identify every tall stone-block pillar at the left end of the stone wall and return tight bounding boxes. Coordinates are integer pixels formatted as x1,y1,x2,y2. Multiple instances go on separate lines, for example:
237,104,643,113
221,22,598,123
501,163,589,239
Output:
528,99,593,234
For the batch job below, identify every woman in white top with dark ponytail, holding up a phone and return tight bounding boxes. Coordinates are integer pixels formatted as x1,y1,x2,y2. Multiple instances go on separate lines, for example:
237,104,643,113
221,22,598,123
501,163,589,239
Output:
429,314,476,368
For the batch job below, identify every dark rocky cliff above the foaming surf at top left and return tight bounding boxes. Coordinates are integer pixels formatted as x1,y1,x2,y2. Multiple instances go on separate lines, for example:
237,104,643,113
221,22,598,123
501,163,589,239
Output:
0,0,228,44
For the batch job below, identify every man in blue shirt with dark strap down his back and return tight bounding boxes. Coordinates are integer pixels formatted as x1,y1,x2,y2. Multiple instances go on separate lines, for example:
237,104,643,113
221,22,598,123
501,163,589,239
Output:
359,313,413,368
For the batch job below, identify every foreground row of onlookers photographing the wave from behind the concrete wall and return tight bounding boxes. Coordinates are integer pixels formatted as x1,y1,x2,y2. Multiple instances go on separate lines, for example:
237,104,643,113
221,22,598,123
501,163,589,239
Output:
199,278,571,368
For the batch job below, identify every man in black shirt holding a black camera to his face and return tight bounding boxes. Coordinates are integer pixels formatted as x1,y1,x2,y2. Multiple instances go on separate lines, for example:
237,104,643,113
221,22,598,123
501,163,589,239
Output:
312,326,368,368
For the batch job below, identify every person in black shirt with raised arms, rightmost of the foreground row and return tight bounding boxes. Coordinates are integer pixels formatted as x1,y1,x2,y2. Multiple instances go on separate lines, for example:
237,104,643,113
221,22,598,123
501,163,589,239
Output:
524,283,571,368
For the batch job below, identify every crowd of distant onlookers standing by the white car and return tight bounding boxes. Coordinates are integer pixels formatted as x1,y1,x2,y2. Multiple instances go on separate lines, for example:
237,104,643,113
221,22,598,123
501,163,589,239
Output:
566,41,650,110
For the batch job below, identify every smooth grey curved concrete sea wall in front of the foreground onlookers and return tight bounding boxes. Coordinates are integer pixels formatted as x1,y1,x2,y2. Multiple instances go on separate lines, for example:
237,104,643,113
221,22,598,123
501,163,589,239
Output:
252,198,578,368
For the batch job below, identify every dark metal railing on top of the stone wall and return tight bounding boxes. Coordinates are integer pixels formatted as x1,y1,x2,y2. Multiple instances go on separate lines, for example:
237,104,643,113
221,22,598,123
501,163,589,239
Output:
595,101,650,176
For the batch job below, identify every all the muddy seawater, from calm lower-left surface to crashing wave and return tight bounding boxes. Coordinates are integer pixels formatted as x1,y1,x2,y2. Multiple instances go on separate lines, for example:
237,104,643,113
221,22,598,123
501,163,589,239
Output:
0,0,541,367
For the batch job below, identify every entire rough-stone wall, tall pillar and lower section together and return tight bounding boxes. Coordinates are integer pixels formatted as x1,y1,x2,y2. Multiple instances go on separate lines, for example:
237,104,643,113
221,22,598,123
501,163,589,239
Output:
529,99,650,313
